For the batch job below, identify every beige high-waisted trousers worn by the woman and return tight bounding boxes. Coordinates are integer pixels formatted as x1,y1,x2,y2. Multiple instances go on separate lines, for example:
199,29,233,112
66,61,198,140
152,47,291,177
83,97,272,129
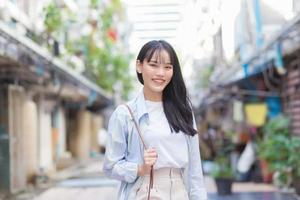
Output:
135,168,189,200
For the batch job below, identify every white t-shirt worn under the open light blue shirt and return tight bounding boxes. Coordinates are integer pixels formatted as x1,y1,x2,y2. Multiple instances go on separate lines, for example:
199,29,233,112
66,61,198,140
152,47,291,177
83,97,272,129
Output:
143,100,188,169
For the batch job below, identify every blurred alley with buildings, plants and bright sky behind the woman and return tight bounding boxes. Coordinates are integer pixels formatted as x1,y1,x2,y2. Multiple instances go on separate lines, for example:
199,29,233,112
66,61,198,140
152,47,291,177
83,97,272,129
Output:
0,0,300,200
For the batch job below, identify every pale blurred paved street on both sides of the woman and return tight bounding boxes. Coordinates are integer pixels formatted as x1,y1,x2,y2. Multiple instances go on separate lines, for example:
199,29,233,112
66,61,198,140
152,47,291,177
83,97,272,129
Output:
3,159,299,200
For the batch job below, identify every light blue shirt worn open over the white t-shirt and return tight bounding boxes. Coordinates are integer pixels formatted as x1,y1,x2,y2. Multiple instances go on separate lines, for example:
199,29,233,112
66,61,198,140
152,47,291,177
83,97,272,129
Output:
103,91,207,200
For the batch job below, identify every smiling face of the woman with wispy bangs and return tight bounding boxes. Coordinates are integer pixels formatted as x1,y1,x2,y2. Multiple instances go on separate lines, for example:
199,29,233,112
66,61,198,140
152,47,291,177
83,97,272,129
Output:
137,50,173,95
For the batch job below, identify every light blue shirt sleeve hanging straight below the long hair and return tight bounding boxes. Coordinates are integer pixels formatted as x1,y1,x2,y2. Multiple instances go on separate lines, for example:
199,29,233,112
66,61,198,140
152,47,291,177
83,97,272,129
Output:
188,113,207,200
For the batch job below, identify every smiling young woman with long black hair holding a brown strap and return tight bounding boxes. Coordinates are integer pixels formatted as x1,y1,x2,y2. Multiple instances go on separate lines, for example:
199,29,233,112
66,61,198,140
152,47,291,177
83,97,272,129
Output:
103,40,207,200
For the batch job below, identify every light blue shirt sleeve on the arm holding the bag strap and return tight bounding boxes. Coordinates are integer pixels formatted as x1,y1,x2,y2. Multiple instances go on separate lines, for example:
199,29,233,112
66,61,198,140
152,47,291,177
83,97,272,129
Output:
103,106,138,183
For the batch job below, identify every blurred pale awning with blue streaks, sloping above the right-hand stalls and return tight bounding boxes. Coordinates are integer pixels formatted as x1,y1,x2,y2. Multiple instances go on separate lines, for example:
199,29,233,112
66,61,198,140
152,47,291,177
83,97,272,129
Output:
214,14,300,85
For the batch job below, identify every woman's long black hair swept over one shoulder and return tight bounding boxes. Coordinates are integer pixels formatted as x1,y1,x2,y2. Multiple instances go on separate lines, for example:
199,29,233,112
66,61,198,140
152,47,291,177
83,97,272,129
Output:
136,40,197,136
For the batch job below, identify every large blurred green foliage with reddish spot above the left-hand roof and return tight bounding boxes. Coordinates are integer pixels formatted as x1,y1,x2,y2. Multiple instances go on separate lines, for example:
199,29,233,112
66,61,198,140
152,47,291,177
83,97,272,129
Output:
40,0,134,99
